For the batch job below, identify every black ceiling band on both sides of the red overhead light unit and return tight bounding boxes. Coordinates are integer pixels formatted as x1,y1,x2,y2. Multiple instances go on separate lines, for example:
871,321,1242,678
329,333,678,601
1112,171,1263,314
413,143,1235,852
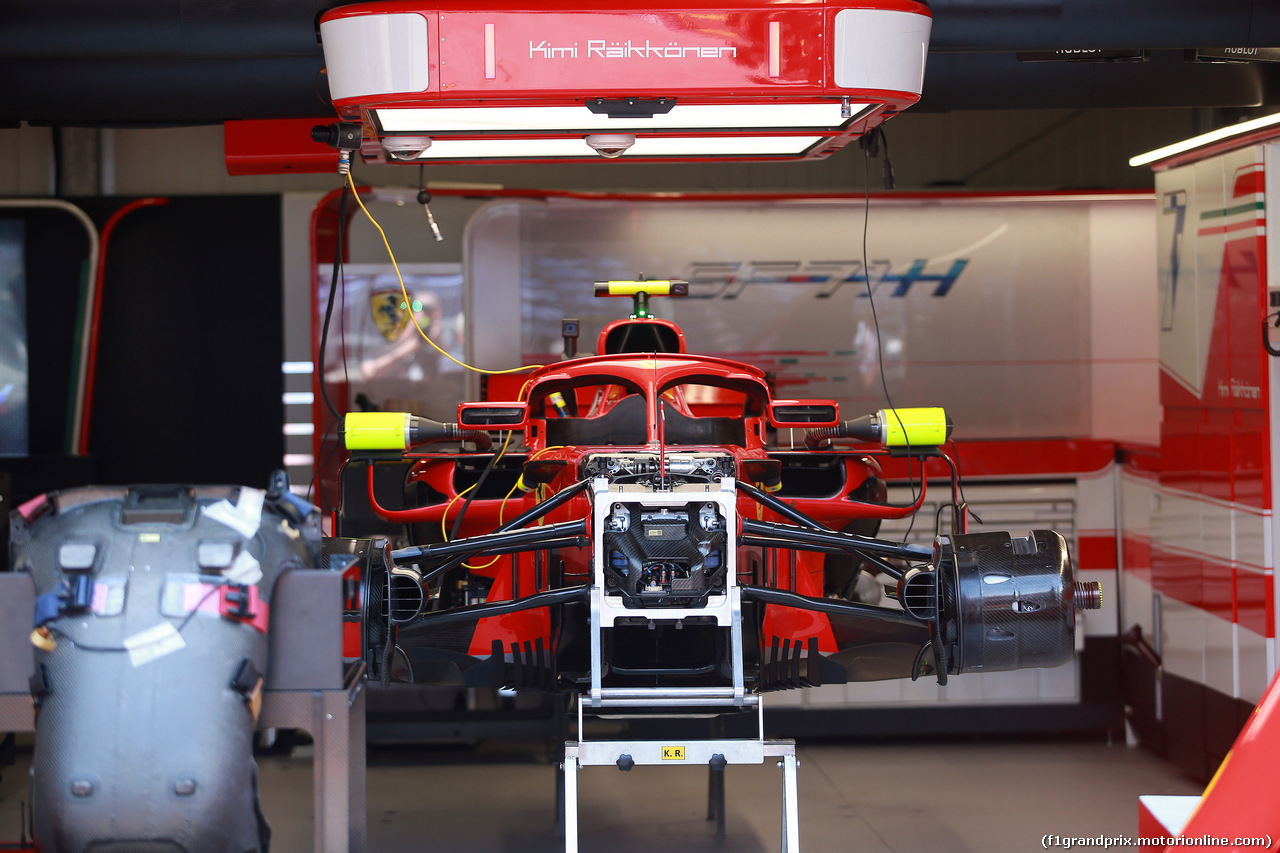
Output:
0,0,1280,126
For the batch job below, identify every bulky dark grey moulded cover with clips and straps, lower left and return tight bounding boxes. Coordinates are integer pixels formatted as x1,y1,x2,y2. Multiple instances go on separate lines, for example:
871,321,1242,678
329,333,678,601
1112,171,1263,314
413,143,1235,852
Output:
10,473,320,853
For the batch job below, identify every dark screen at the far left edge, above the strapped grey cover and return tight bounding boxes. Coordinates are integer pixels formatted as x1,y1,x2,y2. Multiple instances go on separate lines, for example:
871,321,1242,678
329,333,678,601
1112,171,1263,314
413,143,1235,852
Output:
0,219,29,456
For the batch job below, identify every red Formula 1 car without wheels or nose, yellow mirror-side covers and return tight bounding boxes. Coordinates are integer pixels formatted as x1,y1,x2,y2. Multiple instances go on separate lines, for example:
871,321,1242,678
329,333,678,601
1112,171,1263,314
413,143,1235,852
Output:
329,280,1101,713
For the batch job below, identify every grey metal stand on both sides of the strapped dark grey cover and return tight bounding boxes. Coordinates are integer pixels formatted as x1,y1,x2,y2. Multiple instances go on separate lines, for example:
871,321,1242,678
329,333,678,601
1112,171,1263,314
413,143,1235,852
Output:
0,570,366,853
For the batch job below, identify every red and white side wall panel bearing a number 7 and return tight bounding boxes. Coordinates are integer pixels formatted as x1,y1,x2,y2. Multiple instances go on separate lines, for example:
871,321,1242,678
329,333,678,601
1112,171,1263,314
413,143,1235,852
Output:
1152,147,1275,678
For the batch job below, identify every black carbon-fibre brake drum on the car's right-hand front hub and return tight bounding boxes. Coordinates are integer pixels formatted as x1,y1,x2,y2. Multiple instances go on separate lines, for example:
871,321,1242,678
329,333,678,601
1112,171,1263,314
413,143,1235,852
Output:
934,530,1102,675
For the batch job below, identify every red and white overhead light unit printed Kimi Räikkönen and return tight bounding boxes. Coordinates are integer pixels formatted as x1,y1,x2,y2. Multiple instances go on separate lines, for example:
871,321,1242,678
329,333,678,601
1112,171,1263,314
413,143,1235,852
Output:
308,0,932,163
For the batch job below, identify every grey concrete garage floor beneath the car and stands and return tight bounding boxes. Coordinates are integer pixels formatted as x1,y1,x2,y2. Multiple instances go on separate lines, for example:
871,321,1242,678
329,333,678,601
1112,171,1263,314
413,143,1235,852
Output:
0,739,1201,853
